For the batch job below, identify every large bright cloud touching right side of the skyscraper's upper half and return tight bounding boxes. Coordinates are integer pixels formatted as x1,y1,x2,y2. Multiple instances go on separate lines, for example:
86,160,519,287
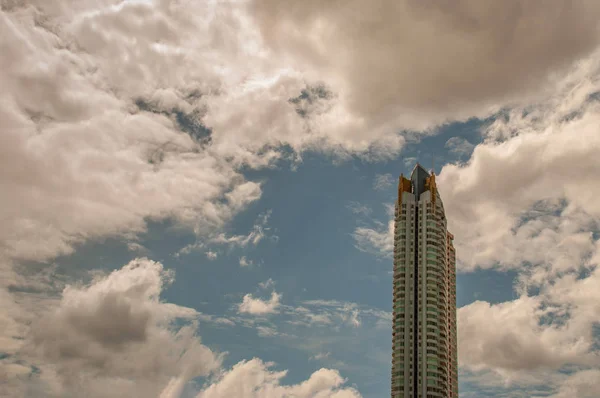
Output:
438,51,600,269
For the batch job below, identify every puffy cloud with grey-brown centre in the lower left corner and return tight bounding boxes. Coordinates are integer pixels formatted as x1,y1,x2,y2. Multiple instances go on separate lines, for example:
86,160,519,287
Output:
17,258,222,397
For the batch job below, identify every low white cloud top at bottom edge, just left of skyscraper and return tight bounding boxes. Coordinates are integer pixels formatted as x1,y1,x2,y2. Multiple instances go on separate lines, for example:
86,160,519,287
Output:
197,359,360,398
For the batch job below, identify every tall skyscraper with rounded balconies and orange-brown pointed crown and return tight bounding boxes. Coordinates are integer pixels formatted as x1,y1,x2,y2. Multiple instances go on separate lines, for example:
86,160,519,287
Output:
392,163,458,398
